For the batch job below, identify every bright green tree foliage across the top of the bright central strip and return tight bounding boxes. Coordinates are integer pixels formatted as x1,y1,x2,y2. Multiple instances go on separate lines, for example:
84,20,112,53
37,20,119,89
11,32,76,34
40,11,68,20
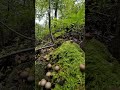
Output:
35,0,85,40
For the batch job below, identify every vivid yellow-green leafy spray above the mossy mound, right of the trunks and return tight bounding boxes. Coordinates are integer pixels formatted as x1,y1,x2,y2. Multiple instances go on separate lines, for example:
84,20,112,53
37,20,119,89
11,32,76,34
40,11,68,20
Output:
52,4,85,29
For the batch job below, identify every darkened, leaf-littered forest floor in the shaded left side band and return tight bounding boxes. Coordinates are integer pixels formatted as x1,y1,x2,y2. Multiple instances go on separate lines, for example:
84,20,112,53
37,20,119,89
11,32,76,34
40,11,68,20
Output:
0,42,35,90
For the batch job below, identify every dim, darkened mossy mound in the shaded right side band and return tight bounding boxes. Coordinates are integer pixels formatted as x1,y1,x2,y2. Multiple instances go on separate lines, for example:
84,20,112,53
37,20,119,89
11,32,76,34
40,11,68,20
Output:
85,39,120,90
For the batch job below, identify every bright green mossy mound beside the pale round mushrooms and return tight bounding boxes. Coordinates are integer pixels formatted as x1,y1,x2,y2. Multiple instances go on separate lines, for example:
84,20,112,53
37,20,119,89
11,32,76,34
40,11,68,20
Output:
50,41,85,90
